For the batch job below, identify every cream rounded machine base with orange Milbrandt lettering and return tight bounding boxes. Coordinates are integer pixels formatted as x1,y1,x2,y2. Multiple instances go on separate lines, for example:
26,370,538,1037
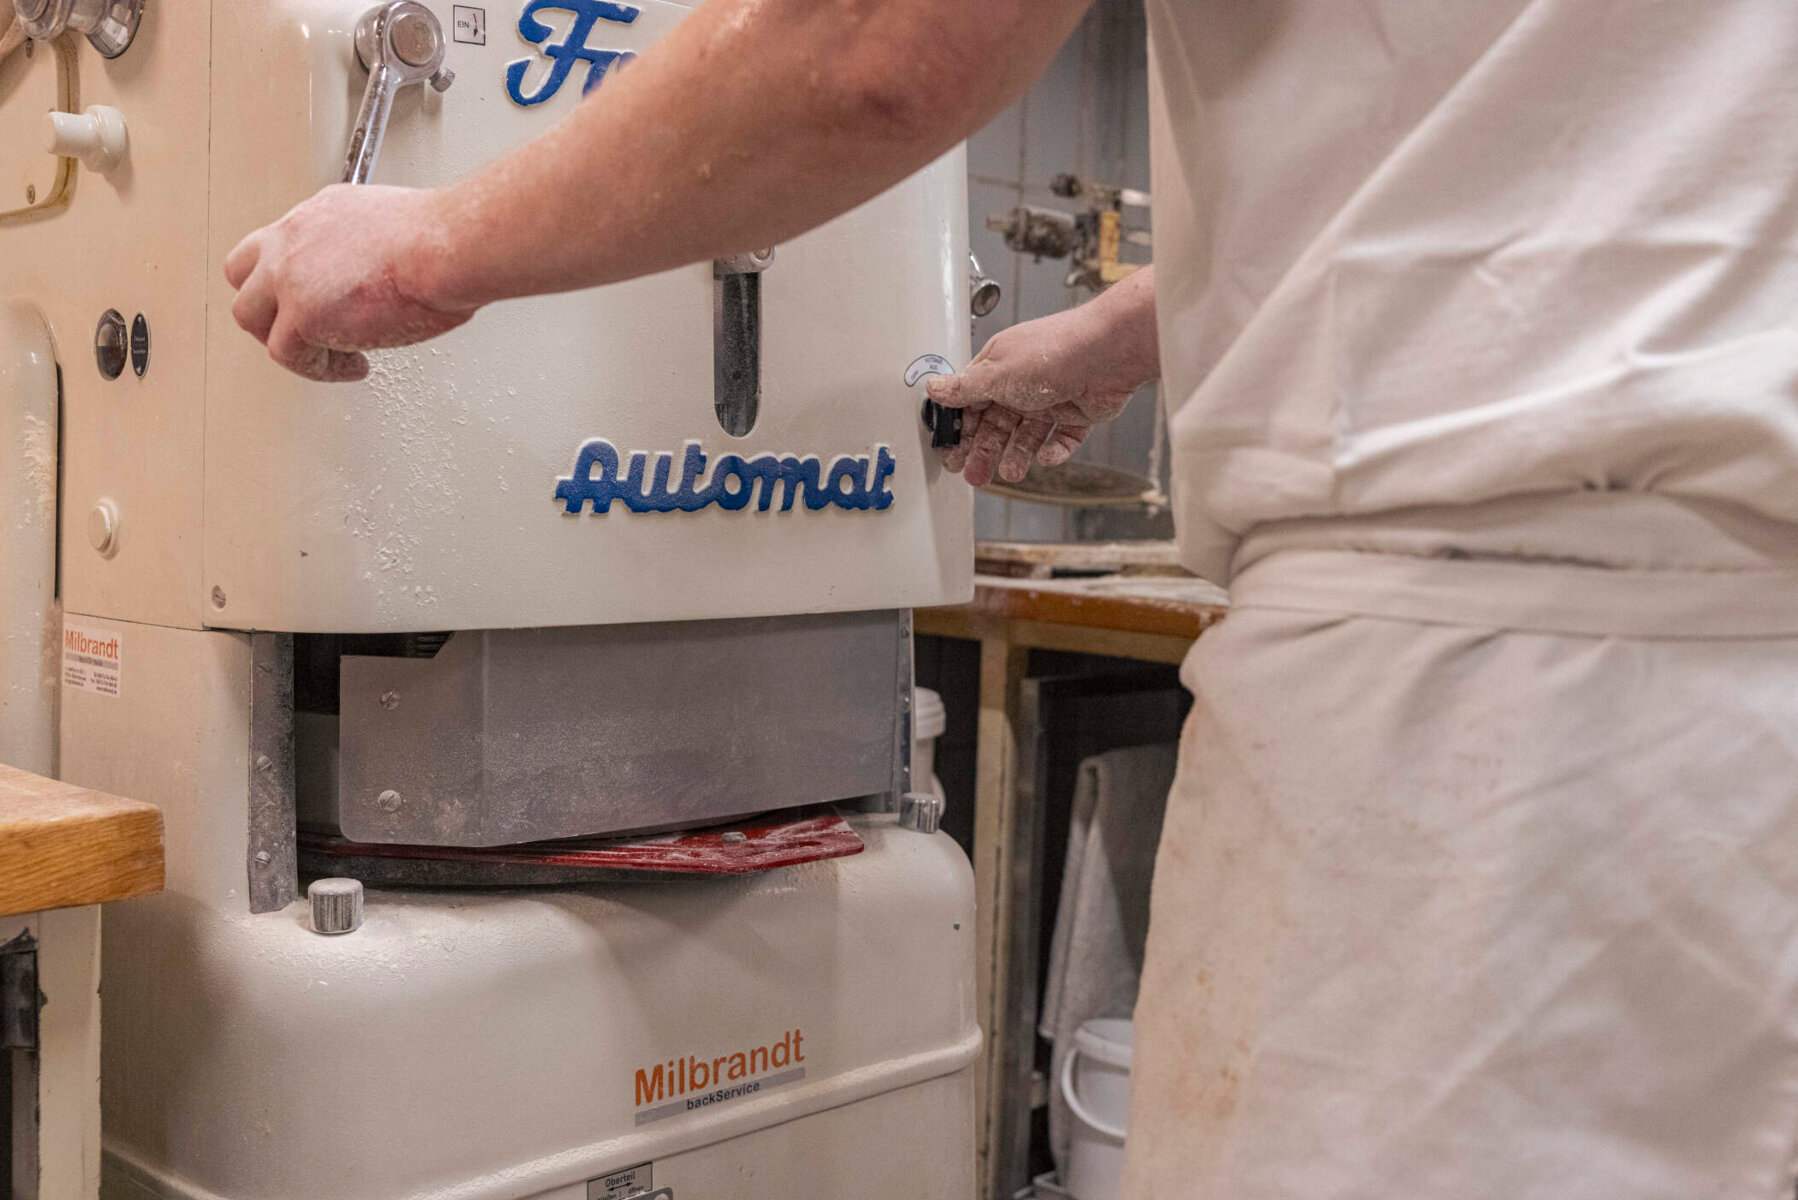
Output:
102,817,980,1200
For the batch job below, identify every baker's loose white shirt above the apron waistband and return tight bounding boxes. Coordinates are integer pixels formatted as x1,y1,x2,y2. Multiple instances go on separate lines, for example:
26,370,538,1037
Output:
1147,0,1798,583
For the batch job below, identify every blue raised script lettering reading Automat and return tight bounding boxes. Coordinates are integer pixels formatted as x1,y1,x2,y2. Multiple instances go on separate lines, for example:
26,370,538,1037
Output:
556,437,899,515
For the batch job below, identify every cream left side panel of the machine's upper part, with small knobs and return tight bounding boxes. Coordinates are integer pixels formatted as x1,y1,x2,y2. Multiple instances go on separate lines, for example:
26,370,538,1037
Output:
36,0,218,626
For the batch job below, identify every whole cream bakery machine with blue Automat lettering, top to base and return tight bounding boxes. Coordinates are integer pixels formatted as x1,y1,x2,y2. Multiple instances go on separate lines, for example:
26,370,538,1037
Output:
0,0,980,1200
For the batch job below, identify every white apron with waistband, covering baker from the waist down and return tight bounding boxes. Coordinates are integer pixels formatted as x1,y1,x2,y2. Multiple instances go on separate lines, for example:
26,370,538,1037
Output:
1124,498,1798,1200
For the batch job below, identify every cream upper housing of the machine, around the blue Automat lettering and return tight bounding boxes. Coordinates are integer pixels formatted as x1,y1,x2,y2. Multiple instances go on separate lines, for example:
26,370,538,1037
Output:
31,0,973,633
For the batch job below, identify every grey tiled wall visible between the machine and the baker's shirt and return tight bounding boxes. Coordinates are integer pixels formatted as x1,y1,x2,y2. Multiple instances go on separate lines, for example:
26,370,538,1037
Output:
967,0,1154,542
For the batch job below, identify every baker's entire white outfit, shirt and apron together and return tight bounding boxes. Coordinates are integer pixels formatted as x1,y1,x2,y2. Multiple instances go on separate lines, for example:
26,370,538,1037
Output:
1126,0,1798,1200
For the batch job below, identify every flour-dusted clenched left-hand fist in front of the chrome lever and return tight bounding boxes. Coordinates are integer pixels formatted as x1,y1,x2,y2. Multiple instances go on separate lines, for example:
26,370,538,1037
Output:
225,184,473,383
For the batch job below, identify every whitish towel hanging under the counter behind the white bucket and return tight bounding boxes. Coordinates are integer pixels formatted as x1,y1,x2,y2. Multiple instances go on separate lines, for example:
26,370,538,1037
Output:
1037,743,1179,1175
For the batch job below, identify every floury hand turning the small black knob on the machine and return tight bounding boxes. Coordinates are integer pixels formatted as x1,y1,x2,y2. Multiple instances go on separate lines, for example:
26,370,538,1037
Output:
928,302,1154,488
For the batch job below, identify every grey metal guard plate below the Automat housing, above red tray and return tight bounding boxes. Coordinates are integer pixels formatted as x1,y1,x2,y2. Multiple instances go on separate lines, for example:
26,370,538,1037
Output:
338,612,912,846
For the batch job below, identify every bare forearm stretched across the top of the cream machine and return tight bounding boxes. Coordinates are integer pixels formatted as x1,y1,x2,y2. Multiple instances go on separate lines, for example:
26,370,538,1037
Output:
426,0,1090,308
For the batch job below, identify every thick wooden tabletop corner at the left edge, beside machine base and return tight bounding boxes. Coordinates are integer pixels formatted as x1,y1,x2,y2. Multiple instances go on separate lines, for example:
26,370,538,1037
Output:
0,766,162,916
